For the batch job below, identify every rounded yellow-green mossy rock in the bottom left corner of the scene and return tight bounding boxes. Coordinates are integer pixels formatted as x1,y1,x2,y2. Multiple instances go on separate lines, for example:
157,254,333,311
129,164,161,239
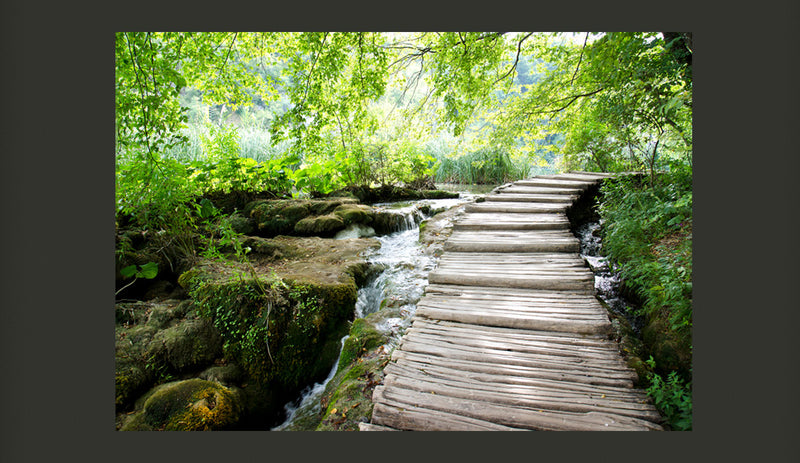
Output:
121,378,243,431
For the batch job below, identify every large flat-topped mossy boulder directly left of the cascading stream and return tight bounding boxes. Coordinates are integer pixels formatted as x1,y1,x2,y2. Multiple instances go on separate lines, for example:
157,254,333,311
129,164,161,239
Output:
179,236,378,417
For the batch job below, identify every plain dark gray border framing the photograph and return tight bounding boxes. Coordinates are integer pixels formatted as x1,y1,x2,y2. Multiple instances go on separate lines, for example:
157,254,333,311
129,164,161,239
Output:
0,0,800,462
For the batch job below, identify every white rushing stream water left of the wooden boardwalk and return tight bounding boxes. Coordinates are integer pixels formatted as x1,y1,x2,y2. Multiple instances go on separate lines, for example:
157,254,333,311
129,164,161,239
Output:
272,193,474,431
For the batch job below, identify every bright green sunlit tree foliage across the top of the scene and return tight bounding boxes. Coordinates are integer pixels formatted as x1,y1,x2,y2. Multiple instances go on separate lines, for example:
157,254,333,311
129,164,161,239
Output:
115,32,692,207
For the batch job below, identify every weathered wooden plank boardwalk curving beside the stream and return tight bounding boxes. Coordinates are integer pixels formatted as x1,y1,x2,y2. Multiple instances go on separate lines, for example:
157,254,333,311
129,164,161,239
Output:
361,173,662,431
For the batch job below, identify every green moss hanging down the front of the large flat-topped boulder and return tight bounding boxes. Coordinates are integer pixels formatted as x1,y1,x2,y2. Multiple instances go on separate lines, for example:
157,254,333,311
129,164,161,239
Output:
183,268,357,402
